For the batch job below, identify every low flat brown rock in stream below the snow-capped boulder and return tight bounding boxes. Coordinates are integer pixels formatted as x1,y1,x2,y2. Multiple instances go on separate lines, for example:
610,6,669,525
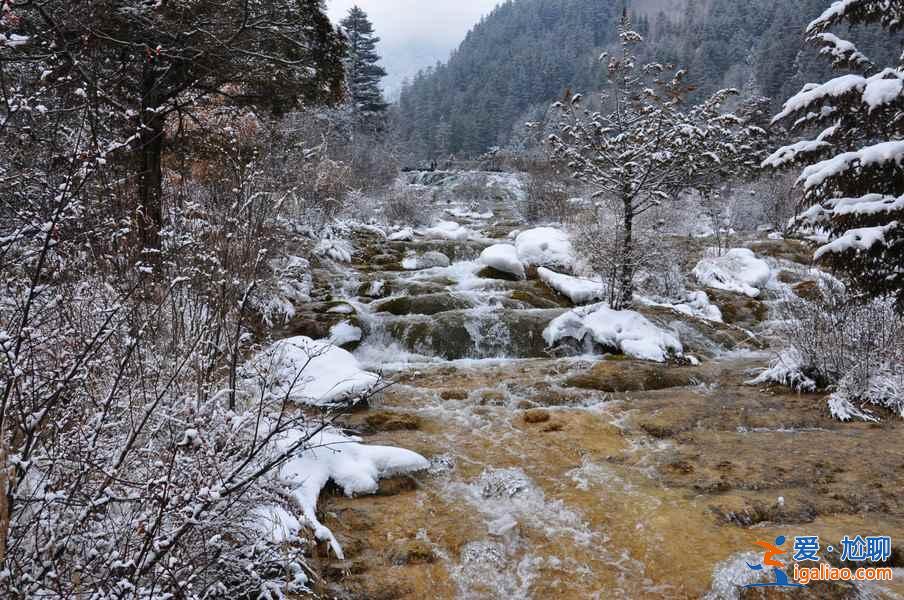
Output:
564,360,705,393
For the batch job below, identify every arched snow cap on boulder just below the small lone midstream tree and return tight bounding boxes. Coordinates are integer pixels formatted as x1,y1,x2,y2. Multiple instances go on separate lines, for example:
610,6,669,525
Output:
543,304,683,362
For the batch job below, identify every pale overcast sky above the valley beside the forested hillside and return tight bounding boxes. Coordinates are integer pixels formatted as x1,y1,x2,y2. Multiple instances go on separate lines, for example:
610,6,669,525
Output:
327,0,501,96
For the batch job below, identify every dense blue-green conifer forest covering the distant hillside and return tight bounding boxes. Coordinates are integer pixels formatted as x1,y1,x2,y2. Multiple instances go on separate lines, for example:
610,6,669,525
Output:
398,0,896,159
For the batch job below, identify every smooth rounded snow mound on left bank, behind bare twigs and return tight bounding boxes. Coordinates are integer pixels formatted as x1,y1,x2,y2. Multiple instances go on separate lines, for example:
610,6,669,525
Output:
244,338,380,406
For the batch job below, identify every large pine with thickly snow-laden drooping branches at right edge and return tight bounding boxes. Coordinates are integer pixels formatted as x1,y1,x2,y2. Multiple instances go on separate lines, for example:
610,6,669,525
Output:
764,0,904,312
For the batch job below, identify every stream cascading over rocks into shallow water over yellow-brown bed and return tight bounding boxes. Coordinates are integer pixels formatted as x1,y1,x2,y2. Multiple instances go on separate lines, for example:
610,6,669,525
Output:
296,174,904,600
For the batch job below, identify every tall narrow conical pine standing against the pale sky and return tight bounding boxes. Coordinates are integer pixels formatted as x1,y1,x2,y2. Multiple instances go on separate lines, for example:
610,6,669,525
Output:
341,6,387,115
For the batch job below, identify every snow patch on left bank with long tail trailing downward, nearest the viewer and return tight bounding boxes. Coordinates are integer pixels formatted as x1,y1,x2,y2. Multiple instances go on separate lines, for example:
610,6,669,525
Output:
279,428,430,559
